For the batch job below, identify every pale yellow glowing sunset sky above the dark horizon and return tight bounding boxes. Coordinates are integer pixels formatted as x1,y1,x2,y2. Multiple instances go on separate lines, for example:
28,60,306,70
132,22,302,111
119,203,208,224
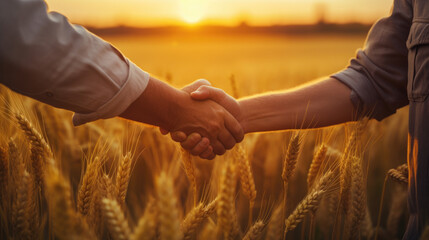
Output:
47,0,393,27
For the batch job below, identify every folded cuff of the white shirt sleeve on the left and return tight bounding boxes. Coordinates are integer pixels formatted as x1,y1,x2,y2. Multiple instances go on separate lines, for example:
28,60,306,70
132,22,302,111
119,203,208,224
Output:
73,60,149,126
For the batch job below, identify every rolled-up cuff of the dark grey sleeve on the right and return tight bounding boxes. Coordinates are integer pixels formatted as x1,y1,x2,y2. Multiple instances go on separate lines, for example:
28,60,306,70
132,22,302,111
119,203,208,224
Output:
331,67,393,121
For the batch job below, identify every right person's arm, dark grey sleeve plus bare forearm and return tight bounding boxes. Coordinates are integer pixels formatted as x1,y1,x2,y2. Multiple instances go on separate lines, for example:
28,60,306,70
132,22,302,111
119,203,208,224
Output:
176,0,413,154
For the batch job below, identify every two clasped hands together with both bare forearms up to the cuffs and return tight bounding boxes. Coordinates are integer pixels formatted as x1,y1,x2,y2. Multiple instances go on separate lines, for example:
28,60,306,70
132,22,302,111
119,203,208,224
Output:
120,77,350,159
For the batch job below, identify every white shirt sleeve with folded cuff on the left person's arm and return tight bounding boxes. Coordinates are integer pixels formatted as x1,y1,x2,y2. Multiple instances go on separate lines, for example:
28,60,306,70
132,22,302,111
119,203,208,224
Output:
0,0,149,125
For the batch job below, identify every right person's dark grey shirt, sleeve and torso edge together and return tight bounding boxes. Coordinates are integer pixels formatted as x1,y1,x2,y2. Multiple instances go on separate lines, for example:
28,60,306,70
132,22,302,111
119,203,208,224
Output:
332,0,429,239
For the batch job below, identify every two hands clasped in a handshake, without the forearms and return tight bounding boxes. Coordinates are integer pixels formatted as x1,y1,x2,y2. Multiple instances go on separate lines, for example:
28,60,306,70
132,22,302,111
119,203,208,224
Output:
160,79,245,159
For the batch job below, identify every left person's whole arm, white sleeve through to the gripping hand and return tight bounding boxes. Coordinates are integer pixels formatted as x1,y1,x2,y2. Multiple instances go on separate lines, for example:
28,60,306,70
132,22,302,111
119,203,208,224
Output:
0,0,243,158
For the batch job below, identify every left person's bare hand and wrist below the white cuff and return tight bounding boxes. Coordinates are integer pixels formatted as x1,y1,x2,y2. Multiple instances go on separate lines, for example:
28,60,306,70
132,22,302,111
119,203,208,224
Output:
119,77,244,159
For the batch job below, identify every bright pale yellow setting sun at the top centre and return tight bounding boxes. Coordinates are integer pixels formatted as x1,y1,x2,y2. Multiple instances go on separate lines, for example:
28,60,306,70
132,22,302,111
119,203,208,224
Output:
179,0,206,24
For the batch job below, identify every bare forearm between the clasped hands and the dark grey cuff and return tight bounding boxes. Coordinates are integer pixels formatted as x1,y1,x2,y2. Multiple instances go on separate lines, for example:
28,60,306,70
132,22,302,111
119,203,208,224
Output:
239,78,357,133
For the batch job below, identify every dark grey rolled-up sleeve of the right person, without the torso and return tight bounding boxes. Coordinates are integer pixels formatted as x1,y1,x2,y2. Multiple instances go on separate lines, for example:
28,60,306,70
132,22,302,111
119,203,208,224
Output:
331,0,413,120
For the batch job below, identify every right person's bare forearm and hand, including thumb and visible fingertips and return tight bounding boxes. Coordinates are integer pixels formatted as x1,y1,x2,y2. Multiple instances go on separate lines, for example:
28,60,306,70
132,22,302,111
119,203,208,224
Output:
171,78,358,155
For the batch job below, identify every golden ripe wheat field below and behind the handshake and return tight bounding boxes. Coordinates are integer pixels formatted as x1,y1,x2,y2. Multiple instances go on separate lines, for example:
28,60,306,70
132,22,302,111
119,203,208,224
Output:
0,33,408,240
